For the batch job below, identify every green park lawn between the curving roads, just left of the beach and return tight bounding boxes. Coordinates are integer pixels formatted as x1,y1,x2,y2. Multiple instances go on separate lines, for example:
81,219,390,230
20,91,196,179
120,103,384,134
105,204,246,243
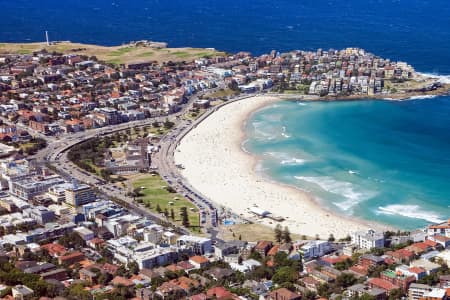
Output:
132,174,199,231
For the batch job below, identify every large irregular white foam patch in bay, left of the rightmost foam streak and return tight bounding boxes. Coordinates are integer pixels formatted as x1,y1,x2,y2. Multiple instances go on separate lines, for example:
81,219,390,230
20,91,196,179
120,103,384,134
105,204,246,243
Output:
295,176,376,211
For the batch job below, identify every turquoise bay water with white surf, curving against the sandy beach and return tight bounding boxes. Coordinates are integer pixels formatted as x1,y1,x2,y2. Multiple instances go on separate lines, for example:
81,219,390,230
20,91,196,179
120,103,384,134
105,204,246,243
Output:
244,97,450,229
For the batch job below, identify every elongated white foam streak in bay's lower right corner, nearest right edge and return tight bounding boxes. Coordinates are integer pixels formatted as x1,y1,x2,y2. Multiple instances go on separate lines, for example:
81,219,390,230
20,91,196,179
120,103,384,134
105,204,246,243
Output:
376,204,444,223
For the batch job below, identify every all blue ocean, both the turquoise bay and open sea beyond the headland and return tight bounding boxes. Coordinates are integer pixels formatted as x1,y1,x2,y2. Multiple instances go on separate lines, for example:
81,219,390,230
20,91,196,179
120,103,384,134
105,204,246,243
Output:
0,0,450,229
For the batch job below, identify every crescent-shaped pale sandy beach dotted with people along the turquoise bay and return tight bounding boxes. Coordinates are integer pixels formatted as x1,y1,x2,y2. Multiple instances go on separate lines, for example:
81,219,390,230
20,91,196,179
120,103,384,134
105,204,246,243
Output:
175,96,387,238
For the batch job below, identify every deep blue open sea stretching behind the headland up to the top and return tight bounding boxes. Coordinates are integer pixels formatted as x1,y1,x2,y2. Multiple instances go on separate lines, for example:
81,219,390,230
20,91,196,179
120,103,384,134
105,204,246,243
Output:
0,0,450,74
